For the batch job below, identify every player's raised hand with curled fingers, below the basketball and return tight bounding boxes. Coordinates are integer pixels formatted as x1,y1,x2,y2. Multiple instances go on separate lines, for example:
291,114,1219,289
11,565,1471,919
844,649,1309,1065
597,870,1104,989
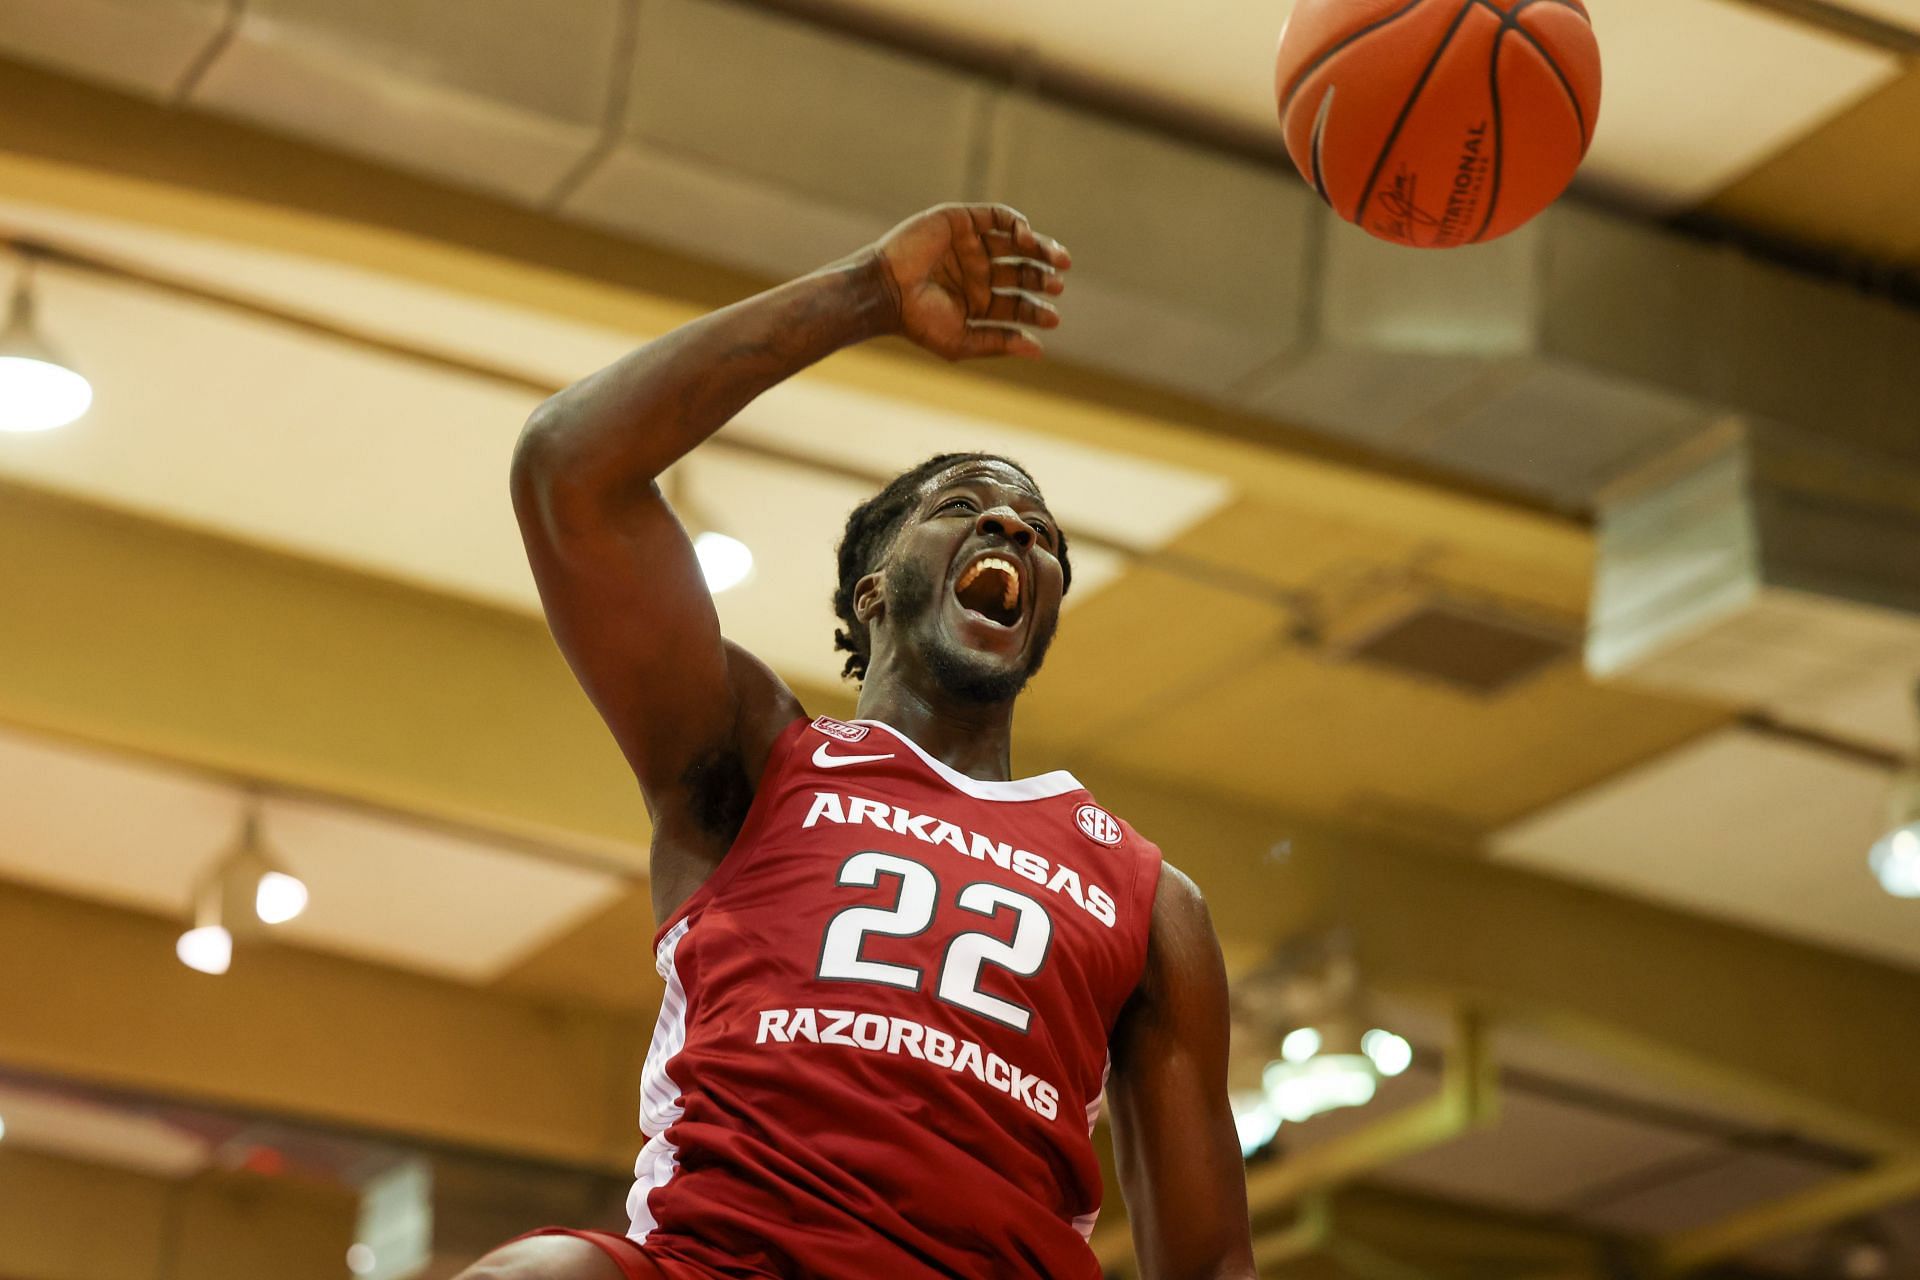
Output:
874,205,1071,361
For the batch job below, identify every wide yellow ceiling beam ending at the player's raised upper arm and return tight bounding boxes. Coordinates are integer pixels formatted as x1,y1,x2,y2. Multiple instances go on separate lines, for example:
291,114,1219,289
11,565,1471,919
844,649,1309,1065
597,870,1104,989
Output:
0,484,649,859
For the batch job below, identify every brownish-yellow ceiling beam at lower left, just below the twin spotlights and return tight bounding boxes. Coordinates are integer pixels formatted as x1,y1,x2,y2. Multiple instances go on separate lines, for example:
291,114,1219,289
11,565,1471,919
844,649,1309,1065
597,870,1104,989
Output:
0,885,647,1173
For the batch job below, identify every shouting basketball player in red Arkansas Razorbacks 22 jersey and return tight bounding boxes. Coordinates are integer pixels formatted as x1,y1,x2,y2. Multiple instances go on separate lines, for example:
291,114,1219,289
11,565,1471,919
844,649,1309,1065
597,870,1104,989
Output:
456,205,1254,1280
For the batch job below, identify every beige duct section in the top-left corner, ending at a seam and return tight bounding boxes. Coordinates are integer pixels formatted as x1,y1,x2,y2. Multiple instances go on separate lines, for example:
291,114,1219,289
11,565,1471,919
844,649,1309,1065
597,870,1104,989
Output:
0,0,228,98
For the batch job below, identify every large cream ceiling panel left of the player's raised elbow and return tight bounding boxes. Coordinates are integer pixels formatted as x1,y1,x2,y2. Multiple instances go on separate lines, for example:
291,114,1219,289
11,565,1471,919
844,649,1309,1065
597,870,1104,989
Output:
0,271,540,608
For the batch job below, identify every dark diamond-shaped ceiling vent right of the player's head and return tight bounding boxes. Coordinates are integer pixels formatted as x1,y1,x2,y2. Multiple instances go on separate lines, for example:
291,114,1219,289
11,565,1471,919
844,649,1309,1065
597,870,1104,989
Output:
1342,597,1576,697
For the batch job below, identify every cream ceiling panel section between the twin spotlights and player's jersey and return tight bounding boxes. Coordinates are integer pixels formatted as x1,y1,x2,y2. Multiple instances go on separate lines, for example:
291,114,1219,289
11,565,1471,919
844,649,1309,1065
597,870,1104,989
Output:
261,798,622,983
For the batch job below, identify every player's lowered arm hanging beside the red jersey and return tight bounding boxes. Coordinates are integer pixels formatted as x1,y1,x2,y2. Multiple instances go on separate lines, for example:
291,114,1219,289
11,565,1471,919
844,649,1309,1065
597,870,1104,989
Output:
1108,865,1256,1280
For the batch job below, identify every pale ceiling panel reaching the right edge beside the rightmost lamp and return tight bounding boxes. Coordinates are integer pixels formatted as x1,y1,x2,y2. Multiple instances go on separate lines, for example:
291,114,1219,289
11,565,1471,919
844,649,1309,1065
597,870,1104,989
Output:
1494,727,1920,967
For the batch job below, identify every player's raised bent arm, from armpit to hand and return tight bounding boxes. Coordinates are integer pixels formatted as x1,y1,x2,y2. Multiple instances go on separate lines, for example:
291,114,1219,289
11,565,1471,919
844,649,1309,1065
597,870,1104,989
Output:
513,205,1068,816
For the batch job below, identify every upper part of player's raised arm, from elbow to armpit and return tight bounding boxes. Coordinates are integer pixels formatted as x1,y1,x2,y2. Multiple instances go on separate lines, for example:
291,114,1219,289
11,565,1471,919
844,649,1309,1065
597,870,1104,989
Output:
515,460,756,802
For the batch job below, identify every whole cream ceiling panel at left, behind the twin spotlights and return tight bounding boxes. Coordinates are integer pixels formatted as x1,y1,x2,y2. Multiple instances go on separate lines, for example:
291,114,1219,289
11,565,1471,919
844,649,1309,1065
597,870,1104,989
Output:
0,731,628,984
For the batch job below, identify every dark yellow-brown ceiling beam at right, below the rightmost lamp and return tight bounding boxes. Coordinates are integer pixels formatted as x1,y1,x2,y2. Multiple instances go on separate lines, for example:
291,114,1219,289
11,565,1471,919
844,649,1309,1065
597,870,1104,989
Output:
1313,842,1920,1155
